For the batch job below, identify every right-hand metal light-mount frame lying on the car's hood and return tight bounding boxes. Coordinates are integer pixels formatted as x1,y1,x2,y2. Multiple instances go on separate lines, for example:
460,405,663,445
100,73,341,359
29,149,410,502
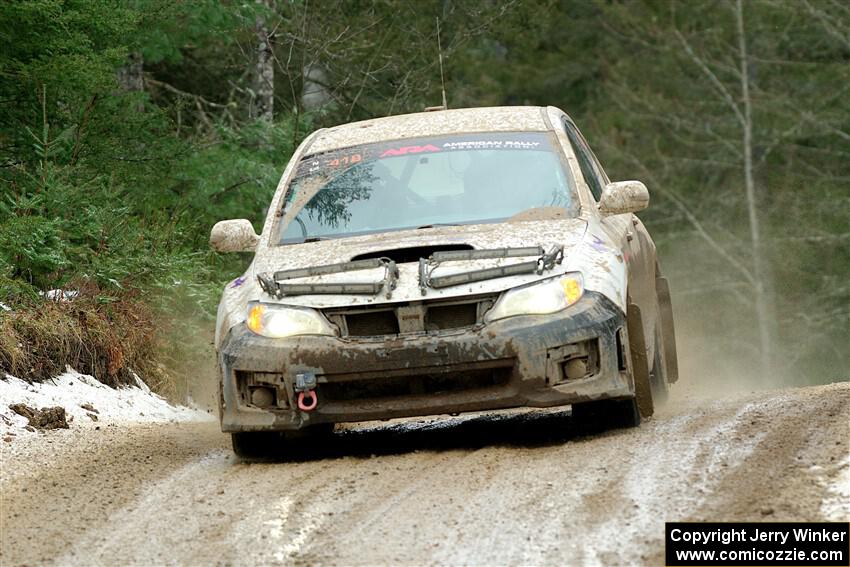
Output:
419,244,564,295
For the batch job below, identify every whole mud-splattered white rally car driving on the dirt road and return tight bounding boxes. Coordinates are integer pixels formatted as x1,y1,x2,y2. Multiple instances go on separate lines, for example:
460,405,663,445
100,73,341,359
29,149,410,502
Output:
210,107,677,456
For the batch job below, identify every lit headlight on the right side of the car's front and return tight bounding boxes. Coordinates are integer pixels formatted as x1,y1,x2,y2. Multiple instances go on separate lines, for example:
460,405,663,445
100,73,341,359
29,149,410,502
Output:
484,272,584,322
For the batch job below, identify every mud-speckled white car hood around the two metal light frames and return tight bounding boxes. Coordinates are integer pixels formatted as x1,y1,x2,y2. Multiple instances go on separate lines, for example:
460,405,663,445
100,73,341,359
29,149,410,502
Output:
246,218,587,308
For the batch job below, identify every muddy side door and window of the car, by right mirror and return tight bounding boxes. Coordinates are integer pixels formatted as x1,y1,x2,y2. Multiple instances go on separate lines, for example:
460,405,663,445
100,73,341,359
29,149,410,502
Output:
564,120,657,342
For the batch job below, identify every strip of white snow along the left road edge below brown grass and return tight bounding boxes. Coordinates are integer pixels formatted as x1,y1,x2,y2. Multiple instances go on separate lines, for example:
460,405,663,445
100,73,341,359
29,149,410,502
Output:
0,368,214,437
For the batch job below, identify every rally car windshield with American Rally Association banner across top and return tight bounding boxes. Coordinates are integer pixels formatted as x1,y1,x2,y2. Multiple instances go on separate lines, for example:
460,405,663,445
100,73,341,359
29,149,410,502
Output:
278,132,578,244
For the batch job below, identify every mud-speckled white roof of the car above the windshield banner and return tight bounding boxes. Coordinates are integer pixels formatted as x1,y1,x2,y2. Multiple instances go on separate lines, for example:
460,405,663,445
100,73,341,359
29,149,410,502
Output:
307,106,551,154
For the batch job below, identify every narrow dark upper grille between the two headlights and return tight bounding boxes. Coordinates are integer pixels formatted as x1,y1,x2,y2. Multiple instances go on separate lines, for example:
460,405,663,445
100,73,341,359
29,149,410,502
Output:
323,295,498,337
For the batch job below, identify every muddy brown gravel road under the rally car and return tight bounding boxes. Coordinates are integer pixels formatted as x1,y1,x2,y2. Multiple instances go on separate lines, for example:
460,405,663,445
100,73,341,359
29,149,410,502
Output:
0,383,850,566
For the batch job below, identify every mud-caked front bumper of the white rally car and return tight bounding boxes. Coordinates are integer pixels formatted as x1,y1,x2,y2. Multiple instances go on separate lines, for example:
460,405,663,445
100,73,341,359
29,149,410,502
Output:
219,292,634,432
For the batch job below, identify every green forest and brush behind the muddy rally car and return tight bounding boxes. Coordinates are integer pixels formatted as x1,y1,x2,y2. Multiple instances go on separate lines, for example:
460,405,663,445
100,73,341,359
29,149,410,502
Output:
0,0,850,399
